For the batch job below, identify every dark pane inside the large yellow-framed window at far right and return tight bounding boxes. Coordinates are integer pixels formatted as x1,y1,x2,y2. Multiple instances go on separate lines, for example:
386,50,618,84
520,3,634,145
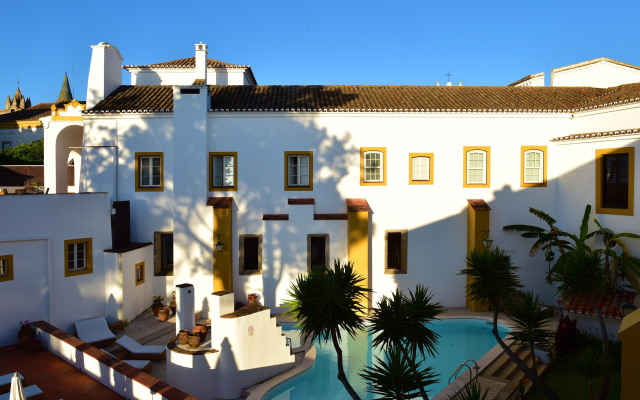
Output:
602,153,629,209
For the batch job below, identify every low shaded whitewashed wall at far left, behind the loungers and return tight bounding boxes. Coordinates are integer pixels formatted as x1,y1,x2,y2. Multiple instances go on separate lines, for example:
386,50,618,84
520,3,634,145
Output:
0,193,111,346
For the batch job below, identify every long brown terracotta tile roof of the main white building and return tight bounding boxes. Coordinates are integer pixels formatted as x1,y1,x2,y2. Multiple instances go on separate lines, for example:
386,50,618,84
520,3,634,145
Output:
88,84,640,113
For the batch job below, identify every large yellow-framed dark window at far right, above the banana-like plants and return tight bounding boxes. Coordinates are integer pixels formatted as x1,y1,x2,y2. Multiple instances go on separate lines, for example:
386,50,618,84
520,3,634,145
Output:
596,147,635,215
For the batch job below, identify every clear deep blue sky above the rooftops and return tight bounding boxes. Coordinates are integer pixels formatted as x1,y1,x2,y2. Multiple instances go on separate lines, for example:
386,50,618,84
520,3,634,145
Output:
0,0,640,108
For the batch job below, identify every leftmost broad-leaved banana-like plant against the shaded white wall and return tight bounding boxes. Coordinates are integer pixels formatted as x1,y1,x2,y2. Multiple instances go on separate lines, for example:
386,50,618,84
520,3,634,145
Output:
502,207,571,280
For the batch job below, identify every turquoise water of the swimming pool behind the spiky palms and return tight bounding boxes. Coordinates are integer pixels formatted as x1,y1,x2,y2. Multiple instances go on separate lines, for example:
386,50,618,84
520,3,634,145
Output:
265,318,509,400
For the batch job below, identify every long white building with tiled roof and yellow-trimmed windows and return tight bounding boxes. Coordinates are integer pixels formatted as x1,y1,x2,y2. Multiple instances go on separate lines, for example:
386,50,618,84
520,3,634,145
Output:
0,42,640,346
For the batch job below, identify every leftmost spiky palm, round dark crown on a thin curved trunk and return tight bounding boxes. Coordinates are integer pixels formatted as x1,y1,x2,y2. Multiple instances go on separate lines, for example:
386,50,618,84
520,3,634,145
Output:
285,260,371,399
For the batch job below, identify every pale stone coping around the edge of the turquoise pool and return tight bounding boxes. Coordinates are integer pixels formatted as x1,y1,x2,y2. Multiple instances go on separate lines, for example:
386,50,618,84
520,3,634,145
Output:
246,308,511,400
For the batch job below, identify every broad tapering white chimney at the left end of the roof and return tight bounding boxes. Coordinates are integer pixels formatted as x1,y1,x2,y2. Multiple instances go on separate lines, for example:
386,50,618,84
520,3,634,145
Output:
87,42,122,110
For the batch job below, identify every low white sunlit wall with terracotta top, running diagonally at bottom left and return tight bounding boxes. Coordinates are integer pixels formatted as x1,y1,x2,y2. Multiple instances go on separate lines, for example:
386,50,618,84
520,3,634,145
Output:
32,321,197,400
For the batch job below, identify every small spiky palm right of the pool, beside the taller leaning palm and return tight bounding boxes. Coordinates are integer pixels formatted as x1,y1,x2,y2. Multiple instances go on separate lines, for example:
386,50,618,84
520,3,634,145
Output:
508,291,554,373
